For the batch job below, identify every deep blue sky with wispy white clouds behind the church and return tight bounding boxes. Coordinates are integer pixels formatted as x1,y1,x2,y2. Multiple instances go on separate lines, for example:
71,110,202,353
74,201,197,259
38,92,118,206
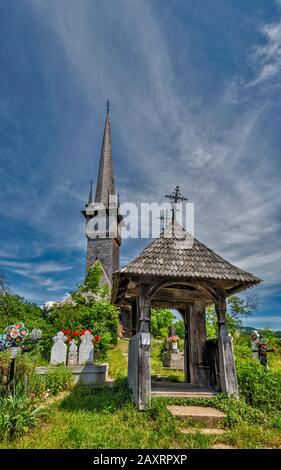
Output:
0,0,281,329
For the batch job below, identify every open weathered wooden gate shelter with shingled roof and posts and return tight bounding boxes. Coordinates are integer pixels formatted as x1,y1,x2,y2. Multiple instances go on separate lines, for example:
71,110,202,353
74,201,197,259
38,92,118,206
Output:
112,221,260,410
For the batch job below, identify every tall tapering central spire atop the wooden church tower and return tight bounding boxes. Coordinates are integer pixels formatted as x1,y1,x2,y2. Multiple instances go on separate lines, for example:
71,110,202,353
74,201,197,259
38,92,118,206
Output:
95,101,115,206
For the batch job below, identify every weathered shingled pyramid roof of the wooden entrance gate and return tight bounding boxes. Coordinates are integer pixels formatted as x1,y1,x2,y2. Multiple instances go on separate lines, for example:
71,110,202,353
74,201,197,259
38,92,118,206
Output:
120,222,261,288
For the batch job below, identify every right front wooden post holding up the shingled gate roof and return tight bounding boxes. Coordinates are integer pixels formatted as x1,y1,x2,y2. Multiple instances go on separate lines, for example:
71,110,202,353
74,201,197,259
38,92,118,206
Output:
215,289,239,396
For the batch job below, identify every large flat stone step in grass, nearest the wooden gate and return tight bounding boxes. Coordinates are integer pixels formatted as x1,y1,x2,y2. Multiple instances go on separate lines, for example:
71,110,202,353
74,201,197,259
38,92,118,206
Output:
167,405,226,424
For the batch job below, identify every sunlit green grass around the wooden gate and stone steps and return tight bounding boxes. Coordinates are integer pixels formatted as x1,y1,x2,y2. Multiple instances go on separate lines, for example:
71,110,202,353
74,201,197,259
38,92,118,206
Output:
0,340,281,449
